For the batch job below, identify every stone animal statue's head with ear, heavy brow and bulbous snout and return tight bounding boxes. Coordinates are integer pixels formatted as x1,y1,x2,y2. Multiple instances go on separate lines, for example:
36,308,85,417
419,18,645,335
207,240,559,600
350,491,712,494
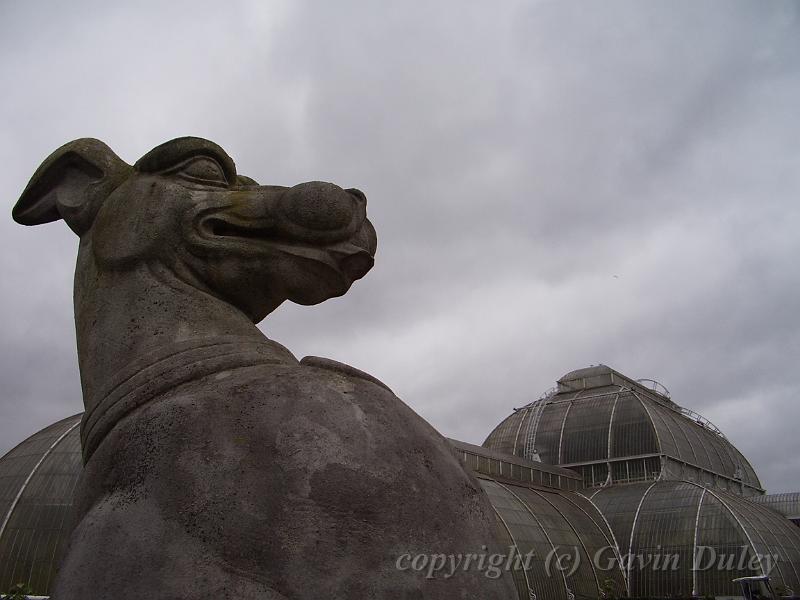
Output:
13,137,376,322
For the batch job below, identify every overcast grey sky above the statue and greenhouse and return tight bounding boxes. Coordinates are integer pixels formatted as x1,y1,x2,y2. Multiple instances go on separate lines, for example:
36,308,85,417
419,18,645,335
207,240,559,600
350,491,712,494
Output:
0,0,800,492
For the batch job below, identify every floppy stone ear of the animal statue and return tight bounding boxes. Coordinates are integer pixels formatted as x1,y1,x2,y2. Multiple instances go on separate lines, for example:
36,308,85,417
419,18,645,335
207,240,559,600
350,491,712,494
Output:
12,138,132,235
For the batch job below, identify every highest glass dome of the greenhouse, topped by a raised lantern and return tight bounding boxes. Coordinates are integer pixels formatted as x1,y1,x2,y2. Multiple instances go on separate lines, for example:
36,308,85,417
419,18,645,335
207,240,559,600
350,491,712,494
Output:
483,365,763,494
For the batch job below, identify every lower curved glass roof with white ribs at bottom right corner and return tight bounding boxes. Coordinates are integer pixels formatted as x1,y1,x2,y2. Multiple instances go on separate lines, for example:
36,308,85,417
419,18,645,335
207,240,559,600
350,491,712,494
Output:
590,481,800,598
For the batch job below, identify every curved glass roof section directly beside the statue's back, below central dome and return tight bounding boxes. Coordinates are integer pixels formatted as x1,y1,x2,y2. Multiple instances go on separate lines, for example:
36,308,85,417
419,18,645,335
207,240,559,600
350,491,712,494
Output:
450,440,627,600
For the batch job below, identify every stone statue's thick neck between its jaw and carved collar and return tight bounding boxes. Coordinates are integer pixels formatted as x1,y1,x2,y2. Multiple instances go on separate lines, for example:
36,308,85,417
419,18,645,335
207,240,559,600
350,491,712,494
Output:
75,256,293,412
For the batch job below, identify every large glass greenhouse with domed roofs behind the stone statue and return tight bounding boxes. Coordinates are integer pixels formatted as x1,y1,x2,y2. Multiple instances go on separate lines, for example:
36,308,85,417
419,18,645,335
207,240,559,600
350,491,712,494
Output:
0,365,800,600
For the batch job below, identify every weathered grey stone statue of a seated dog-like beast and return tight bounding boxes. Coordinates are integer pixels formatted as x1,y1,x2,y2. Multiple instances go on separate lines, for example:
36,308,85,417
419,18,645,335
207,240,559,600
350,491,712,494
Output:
13,137,516,600
